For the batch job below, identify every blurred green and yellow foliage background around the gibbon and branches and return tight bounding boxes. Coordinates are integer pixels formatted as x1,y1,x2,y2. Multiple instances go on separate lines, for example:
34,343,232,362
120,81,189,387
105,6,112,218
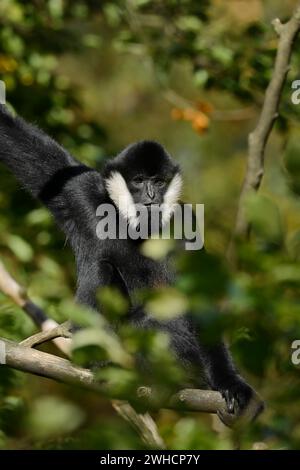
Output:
0,0,300,449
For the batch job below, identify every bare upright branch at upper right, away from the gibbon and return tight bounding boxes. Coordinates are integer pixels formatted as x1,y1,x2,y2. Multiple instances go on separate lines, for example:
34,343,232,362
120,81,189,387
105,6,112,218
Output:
229,6,300,244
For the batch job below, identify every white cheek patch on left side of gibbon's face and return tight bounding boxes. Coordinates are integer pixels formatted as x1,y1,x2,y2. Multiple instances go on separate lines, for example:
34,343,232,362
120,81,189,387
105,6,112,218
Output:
105,171,138,227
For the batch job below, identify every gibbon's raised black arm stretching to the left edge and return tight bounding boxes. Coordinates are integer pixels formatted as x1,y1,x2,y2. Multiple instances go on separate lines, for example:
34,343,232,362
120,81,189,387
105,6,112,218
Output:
0,105,104,239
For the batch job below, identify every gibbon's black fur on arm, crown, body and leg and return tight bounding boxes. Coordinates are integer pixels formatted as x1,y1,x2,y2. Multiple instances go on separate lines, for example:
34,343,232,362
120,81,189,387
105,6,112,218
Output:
0,106,253,412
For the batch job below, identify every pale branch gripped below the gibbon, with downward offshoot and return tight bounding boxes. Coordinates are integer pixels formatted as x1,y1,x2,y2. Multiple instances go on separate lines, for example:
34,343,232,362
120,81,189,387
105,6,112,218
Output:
0,338,261,426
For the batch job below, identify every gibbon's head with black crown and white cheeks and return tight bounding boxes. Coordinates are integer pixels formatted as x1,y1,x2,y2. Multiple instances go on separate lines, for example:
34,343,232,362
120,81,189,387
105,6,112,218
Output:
103,141,182,225
